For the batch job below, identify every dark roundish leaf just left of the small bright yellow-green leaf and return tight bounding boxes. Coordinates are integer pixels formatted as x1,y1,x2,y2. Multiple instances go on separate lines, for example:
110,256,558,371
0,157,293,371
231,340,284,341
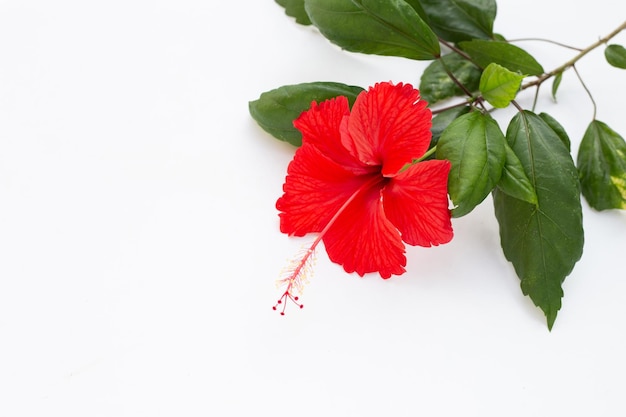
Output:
419,54,481,104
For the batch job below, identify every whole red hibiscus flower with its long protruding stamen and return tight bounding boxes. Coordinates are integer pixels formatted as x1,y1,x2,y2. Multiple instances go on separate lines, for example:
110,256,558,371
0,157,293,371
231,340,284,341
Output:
274,83,453,314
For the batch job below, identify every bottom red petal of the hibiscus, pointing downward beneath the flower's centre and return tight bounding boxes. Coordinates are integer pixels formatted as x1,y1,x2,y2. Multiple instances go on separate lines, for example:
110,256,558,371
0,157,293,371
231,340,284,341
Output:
323,181,406,278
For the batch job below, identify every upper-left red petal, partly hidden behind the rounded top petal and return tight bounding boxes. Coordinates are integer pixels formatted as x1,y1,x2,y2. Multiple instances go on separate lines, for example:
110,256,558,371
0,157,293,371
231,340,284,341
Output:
293,96,367,174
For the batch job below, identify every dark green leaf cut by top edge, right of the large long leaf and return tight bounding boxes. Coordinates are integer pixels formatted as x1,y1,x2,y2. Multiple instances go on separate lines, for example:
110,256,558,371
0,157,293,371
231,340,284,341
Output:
420,0,496,42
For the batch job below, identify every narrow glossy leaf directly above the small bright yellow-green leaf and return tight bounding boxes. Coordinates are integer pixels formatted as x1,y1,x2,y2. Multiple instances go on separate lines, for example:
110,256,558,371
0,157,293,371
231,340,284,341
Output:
459,39,544,75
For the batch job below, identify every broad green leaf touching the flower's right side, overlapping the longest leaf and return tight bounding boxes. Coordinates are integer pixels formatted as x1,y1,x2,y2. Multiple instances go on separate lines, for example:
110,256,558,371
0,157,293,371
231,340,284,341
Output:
437,112,506,217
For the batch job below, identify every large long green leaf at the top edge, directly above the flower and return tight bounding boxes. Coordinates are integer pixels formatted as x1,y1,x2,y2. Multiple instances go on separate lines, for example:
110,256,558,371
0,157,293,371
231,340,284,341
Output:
304,0,441,60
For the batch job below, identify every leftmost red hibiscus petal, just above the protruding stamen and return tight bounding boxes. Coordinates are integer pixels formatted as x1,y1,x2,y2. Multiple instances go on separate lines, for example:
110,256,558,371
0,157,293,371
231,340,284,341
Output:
276,143,362,236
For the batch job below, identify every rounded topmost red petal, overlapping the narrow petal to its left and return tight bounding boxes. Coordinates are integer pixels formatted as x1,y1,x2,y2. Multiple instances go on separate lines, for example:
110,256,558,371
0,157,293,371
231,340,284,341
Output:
342,83,432,177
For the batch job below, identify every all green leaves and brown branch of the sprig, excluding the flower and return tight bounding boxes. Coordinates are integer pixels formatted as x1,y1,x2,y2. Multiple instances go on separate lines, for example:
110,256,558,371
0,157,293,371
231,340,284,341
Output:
249,0,626,329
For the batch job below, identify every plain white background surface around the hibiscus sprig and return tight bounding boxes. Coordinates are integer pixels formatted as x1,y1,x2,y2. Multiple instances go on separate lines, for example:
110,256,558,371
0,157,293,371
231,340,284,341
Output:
0,0,626,416
